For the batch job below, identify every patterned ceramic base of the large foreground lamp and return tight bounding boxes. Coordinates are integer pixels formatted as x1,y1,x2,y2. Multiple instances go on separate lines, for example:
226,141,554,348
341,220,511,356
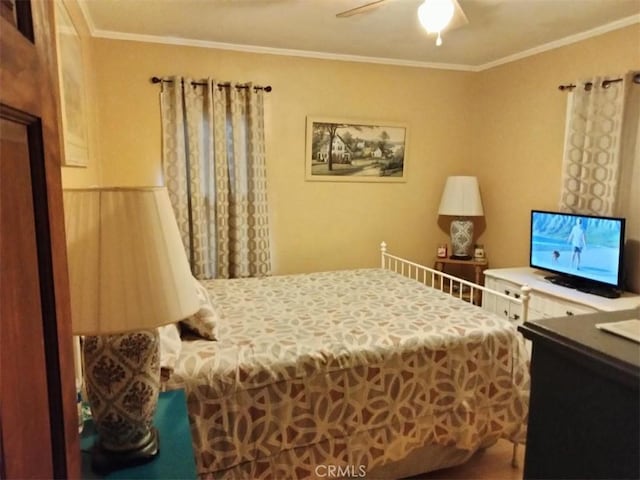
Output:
83,329,160,473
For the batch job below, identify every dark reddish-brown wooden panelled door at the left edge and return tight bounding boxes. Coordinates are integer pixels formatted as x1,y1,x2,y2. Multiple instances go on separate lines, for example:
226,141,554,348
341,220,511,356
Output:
0,0,80,478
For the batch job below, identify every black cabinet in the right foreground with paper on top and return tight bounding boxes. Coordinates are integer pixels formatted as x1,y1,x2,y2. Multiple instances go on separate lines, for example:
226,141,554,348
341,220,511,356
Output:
519,309,640,479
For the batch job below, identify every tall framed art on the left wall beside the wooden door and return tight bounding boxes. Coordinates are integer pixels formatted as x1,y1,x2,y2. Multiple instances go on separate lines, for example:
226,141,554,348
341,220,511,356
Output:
55,1,89,167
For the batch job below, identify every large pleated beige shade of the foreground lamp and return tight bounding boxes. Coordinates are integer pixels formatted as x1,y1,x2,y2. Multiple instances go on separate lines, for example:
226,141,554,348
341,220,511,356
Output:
64,187,198,335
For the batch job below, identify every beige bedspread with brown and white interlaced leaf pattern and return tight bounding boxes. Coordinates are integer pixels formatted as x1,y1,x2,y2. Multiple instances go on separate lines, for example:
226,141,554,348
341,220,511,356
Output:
168,269,529,478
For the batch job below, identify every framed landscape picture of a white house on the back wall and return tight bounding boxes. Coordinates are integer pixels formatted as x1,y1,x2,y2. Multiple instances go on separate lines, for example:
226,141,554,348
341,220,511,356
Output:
305,117,408,182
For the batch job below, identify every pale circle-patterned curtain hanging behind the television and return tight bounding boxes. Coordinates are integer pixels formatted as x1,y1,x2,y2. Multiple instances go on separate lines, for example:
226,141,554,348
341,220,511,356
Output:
560,75,628,215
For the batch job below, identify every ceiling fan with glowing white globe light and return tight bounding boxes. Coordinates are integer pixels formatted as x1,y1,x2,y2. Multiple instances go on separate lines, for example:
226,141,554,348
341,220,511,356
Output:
336,0,469,45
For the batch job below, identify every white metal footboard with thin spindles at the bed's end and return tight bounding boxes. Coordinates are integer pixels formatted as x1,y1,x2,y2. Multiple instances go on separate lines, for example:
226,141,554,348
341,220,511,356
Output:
380,242,531,322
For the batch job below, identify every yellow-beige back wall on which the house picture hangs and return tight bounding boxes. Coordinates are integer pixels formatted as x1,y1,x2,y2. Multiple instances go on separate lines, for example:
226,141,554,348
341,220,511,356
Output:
95,40,474,273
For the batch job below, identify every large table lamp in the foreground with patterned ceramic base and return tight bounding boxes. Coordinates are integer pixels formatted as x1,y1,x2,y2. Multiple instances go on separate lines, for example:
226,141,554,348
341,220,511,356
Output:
63,187,199,473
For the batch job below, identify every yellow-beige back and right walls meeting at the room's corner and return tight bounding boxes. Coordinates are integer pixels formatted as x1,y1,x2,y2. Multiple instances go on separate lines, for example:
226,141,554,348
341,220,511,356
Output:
87,26,640,284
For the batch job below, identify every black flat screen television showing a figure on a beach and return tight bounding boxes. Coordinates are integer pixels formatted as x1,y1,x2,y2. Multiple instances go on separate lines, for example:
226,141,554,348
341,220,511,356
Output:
529,210,625,298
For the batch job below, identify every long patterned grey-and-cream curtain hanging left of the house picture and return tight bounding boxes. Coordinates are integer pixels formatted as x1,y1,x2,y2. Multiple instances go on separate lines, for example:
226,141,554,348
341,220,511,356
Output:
160,77,271,279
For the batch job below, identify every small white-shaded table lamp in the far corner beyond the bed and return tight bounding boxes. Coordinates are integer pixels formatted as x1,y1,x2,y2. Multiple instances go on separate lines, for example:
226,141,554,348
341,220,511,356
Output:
438,176,484,260
